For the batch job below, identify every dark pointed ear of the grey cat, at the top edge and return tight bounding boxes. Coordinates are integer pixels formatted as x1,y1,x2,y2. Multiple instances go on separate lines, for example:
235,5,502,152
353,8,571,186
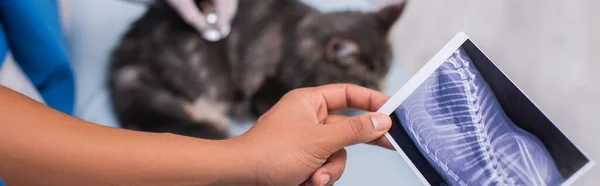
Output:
375,1,406,34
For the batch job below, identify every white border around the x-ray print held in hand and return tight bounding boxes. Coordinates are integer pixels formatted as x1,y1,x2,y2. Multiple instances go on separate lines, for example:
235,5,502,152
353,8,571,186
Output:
377,32,595,186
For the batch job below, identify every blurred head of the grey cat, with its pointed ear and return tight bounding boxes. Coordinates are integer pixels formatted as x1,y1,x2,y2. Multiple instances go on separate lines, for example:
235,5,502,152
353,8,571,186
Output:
280,3,404,90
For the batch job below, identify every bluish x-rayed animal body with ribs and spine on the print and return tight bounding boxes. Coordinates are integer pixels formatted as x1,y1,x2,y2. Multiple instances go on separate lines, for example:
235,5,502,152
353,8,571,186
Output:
394,48,565,186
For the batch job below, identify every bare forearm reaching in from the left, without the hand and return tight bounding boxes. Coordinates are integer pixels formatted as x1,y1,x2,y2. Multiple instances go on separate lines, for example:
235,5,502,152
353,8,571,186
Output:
0,86,249,185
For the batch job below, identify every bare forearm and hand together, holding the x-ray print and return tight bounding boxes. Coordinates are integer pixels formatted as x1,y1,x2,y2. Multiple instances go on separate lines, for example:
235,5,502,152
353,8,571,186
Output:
0,84,392,186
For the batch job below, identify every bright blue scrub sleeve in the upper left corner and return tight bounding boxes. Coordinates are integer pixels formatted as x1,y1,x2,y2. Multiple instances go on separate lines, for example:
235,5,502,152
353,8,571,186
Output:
0,0,75,114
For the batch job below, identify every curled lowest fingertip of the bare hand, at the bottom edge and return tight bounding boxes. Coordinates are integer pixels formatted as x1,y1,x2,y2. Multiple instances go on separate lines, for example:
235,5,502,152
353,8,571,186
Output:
308,149,347,186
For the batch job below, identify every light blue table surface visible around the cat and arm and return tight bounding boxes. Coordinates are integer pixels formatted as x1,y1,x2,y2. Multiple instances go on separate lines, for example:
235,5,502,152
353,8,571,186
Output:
68,0,421,186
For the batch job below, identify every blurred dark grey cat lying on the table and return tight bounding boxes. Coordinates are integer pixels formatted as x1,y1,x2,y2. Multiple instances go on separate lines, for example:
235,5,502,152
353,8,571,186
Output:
108,0,404,139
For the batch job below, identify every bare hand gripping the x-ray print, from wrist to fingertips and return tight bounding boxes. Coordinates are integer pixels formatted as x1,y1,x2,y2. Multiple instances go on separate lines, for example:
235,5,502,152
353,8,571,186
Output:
231,84,393,186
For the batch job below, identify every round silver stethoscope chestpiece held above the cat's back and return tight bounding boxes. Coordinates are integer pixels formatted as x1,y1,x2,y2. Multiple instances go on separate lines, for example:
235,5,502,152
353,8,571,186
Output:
124,0,231,42
